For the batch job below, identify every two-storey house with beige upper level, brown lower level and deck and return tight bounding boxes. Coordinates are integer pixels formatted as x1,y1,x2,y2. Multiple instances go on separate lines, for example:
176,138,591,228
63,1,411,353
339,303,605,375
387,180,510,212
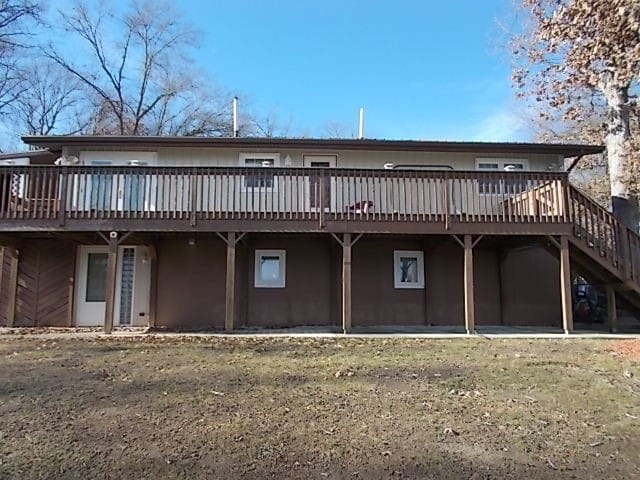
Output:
0,136,640,332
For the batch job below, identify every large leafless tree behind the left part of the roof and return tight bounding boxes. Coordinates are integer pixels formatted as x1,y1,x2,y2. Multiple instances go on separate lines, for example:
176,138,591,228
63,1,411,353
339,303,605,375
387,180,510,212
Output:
44,0,229,135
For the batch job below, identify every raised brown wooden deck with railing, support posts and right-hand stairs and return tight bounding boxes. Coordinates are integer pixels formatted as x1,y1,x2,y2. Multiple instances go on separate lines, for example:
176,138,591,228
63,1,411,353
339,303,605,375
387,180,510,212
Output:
0,166,640,333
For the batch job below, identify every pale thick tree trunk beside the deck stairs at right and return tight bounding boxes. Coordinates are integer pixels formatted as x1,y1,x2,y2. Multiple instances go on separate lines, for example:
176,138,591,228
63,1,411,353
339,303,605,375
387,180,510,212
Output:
602,81,640,231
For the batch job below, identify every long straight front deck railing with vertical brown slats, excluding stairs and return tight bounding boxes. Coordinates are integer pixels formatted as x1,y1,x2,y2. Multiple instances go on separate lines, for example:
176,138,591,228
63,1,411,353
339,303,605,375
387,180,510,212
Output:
0,166,568,224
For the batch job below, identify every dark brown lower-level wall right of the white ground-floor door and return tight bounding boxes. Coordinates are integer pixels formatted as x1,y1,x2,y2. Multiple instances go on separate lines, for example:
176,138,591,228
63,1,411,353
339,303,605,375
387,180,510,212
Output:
150,234,560,329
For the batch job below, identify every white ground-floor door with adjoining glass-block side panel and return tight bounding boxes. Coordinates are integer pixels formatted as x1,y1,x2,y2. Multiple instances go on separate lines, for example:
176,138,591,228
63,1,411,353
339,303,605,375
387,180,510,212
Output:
75,246,150,327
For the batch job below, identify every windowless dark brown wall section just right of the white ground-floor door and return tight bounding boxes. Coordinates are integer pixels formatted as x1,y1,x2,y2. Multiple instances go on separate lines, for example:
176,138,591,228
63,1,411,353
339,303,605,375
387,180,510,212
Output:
156,237,226,329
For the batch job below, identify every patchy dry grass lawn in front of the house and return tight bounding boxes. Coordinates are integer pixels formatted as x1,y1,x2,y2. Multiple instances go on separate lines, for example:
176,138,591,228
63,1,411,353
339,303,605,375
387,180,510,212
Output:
0,336,640,480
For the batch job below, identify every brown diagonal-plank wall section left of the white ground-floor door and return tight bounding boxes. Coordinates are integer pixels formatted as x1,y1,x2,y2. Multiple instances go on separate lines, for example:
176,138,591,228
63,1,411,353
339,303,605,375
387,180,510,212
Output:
14,239,75,327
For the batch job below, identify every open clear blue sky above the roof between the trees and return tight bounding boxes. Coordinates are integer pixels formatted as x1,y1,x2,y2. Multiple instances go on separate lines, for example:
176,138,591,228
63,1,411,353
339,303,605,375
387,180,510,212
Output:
178,0,529,141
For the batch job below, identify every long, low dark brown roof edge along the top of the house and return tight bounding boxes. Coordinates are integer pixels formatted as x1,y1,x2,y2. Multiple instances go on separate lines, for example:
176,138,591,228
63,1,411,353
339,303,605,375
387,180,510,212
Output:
22,135,604,157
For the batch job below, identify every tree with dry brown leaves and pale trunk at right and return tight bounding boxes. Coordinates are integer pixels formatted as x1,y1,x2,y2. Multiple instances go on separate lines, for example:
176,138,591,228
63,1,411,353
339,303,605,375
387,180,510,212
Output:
513,0,640,229
